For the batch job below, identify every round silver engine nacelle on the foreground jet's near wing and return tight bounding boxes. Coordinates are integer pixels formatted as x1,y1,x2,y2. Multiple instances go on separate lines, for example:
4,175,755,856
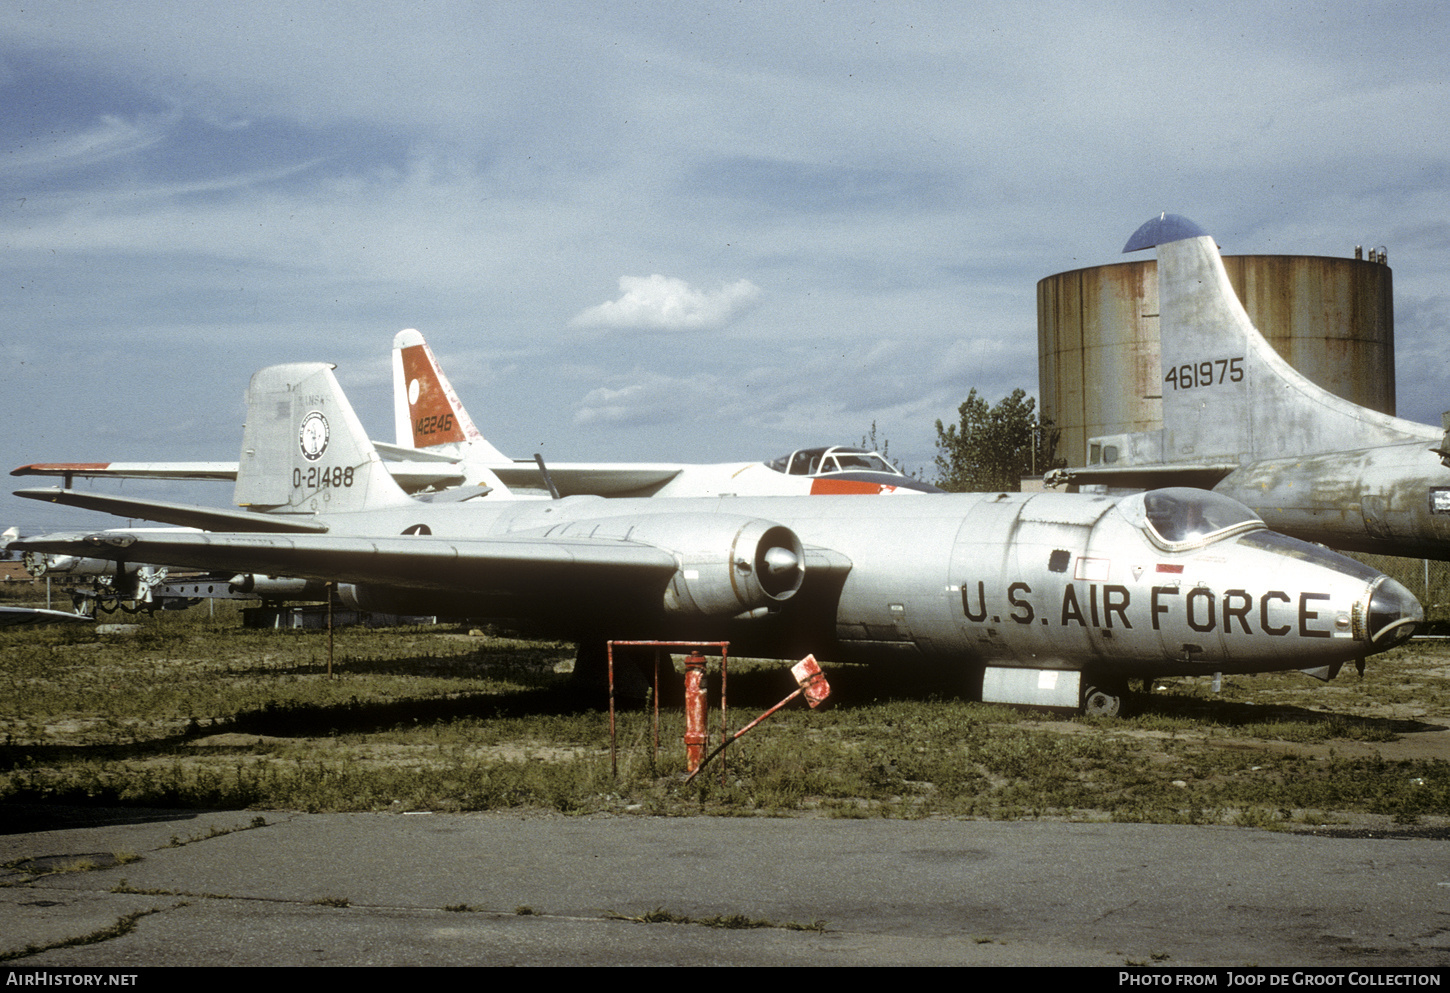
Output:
533,513,805,618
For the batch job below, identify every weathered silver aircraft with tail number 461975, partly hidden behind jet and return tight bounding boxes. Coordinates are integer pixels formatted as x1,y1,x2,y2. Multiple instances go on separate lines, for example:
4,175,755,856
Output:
1047,215,1450,560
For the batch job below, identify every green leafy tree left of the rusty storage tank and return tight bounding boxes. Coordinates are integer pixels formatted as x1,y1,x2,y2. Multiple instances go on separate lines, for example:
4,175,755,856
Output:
934,390,1067,493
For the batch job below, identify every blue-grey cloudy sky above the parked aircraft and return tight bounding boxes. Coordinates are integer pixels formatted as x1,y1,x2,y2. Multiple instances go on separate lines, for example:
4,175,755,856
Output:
0,0,1450,532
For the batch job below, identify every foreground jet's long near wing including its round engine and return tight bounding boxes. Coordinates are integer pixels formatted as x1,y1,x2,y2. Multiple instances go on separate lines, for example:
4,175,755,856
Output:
12,527,853,622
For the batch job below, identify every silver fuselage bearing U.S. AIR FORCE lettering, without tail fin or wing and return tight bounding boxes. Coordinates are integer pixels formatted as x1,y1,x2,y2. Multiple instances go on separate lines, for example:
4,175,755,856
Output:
294,491,1420,678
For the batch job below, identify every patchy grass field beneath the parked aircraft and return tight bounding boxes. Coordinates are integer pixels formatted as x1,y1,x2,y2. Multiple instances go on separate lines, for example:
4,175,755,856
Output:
0,603,1450,829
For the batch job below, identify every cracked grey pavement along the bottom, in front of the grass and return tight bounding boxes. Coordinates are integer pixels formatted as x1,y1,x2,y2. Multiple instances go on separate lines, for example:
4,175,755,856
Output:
0,807,1450,968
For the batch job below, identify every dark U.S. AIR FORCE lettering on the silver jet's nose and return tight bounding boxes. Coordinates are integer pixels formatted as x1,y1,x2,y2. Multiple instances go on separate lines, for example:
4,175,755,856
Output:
961,580,1334,638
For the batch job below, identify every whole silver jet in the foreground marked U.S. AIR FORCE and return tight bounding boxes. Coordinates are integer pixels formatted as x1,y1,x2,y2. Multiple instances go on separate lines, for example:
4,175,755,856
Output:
8,364,1422,713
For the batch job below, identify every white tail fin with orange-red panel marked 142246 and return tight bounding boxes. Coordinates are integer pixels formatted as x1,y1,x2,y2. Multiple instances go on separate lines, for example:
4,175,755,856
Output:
393,329,509,464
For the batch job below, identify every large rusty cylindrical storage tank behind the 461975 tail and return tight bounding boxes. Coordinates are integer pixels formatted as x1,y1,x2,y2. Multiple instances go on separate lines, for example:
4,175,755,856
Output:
1037,249,1395,465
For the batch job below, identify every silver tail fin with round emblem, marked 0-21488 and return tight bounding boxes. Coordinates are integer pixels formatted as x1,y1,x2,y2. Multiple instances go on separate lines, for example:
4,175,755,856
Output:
235,362,410,513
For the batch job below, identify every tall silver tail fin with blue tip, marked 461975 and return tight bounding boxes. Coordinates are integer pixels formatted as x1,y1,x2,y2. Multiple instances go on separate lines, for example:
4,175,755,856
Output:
1122,215,1440,461
